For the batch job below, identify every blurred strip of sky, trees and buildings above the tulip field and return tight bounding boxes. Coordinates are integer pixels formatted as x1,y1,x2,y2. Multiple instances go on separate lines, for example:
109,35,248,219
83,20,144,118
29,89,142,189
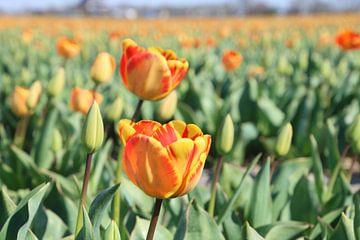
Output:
0,0,360,16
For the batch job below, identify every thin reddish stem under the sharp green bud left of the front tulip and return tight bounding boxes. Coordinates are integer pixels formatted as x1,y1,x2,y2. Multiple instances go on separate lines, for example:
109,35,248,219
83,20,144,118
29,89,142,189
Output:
75,153,93,236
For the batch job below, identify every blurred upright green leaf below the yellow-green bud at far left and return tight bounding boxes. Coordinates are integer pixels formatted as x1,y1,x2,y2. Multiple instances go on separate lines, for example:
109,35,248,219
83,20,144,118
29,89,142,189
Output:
35,107,59,168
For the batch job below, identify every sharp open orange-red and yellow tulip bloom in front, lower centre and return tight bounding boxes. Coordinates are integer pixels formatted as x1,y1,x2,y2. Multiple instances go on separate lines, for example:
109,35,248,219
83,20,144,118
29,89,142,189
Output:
119,119,211,199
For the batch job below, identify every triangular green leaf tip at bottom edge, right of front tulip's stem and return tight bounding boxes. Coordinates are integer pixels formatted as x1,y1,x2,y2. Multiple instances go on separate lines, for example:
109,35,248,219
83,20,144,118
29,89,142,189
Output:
174,200,224,240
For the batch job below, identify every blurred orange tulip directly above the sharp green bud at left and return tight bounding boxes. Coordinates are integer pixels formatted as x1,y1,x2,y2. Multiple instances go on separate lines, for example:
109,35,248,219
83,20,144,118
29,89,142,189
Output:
70,87,103,114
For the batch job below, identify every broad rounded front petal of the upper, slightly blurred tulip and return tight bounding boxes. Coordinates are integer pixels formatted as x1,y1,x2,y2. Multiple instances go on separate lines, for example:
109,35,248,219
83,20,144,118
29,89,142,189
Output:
125,52,171,100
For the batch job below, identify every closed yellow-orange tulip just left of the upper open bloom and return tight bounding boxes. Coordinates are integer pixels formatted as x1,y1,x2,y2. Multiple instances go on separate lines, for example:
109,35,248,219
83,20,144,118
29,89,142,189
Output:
90,52,115,84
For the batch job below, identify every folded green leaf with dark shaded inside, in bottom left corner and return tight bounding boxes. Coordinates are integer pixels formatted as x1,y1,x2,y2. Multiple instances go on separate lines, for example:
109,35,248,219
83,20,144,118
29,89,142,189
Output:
0,183,50,239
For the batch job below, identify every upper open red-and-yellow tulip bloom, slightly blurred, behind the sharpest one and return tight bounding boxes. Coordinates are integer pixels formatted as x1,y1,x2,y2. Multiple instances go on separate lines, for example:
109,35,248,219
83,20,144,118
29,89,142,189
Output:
120,39,189,100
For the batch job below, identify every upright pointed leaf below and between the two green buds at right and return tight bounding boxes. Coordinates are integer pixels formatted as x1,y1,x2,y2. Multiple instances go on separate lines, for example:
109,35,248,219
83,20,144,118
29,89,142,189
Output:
247,160,272,227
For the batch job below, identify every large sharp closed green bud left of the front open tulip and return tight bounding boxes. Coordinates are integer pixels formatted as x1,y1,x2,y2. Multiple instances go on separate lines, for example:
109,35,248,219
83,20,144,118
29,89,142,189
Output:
82,101,104,153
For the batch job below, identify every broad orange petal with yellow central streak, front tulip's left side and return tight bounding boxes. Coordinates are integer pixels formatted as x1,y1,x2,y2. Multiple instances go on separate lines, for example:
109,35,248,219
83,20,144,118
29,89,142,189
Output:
123,134,181,198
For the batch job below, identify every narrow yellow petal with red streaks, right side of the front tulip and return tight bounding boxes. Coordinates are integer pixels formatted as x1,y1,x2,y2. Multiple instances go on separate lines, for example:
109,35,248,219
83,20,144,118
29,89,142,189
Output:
173,135,211,197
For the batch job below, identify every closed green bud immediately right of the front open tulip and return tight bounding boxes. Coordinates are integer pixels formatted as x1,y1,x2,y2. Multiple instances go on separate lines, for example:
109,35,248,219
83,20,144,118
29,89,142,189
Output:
216,114,234,154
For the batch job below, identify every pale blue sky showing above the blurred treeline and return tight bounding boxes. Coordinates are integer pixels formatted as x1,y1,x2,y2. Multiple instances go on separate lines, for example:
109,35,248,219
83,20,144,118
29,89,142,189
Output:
0,0,360,12
